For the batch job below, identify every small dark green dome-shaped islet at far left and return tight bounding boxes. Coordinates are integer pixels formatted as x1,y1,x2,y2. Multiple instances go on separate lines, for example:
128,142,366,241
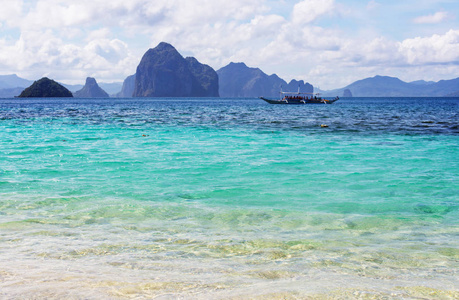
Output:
18,77,73,98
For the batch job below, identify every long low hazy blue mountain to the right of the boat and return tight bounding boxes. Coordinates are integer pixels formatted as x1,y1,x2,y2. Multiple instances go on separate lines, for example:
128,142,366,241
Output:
323,76,459,97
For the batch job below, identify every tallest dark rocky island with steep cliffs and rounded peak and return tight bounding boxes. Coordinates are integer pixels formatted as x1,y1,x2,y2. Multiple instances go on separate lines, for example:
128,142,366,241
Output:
133,42,218,97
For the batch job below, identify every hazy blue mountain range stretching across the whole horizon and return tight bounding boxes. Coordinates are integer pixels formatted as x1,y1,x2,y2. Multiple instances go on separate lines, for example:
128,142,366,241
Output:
0,42,459,98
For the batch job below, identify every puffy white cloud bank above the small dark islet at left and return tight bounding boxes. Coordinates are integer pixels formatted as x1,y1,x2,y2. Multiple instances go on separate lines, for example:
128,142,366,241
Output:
0,30,139,82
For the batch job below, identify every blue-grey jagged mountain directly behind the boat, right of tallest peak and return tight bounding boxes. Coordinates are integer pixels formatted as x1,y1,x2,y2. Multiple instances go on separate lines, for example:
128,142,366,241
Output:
217,63,313,98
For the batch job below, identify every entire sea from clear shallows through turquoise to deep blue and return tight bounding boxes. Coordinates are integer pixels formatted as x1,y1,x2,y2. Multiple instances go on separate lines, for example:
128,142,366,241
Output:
0,98,459,299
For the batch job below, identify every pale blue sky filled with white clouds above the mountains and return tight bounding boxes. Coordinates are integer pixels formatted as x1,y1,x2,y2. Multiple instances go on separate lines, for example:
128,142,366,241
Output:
0,0,459,89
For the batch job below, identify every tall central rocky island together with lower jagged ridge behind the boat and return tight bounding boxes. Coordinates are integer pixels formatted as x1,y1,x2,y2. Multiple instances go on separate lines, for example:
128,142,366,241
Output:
116,43,314,98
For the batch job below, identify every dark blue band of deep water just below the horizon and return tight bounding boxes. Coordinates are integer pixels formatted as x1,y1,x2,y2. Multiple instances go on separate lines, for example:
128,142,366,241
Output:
0,98,459,135
